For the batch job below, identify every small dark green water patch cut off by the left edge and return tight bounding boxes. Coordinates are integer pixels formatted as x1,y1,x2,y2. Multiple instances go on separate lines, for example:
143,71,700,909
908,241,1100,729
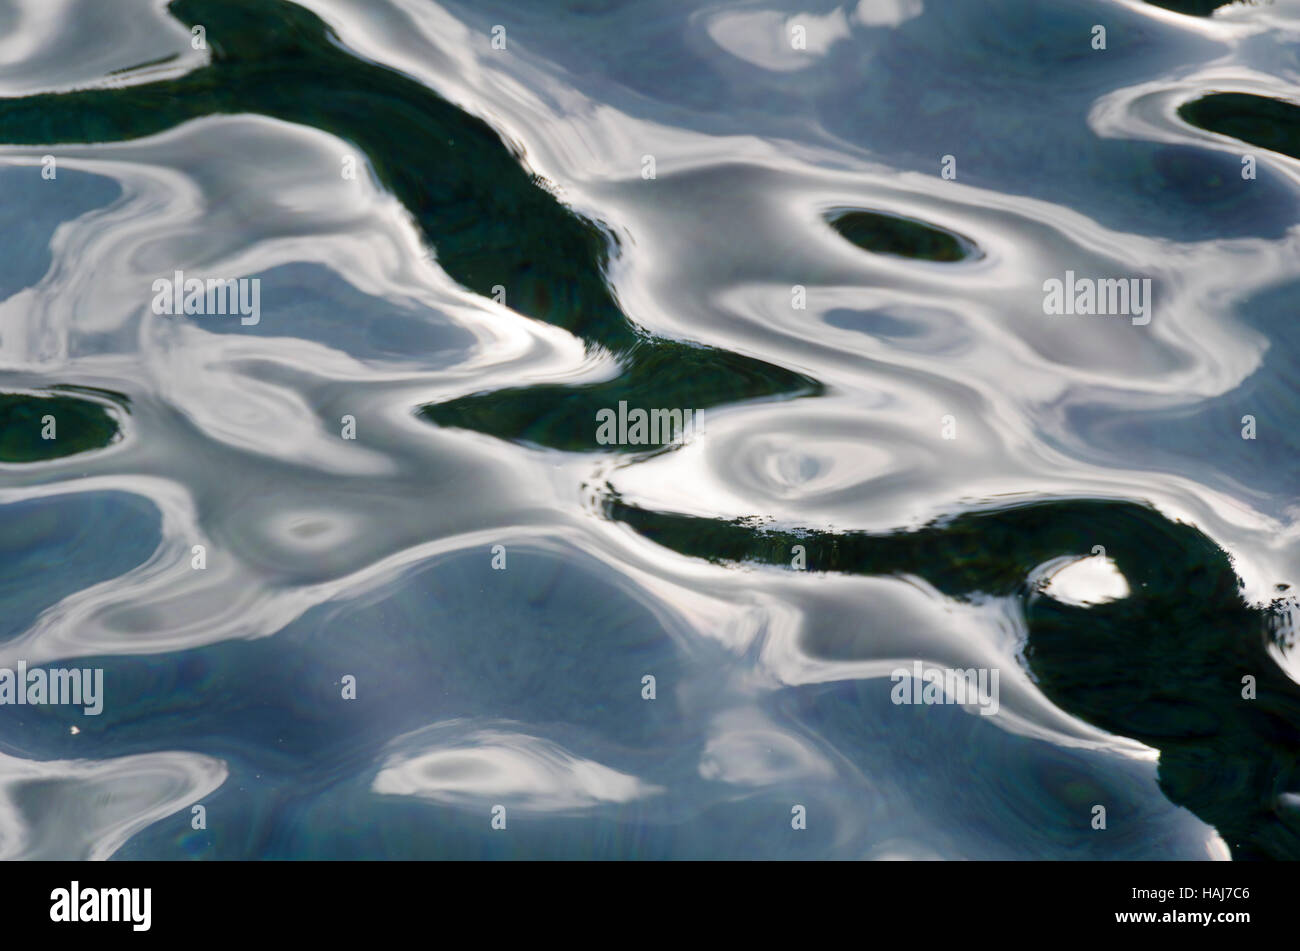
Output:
0,392,125,463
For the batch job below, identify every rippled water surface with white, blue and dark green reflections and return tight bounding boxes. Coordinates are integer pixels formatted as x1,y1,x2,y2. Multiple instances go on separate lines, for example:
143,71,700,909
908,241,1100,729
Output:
0,0,1300,859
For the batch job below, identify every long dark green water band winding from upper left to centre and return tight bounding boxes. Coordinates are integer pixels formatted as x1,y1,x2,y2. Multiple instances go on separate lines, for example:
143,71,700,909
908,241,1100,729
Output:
0,0,822,450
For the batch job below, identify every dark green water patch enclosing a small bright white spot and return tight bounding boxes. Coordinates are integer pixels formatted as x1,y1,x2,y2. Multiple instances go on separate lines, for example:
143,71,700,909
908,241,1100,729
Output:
605,495,1300,860
